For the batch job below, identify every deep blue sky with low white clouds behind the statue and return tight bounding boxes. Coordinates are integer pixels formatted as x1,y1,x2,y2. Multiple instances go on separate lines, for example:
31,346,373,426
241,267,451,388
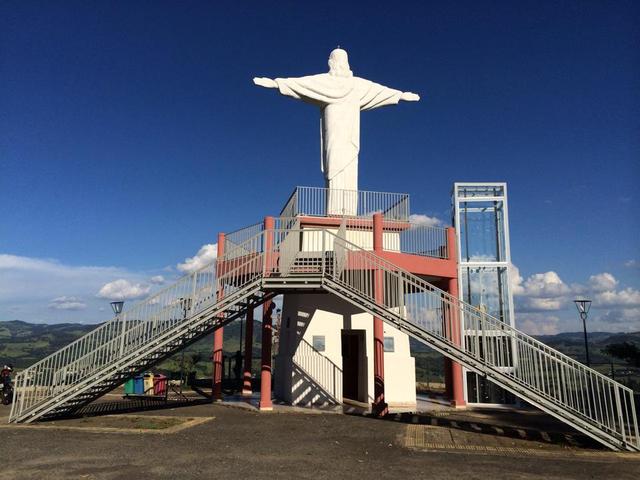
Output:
0,1,640,332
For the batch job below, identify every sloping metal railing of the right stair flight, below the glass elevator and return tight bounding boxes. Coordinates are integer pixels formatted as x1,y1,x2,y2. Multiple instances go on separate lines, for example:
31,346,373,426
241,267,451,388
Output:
325,232,640,449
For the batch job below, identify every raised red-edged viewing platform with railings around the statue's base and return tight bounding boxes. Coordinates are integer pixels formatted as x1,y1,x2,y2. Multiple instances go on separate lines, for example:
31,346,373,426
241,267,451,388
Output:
225,186,457,283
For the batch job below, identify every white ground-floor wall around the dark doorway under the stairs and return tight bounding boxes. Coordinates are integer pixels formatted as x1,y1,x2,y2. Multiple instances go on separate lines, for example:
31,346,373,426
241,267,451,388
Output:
275,294,416,408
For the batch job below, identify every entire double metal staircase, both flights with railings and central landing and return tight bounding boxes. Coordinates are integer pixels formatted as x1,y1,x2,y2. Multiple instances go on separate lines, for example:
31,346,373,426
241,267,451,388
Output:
10,227,640,451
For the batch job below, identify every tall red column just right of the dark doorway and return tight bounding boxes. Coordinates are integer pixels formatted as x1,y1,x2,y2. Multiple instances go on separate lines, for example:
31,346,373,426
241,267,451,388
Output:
371,213,389,416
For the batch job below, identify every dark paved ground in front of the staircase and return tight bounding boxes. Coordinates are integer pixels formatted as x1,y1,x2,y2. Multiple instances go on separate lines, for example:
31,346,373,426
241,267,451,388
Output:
0,402,640,480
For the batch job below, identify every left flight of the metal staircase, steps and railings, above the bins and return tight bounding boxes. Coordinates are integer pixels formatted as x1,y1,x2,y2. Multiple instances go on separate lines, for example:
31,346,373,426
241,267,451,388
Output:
9,234,274,422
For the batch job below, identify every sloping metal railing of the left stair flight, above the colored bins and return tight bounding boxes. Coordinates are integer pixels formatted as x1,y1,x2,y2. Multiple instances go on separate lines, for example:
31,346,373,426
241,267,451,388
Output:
10,233,264,419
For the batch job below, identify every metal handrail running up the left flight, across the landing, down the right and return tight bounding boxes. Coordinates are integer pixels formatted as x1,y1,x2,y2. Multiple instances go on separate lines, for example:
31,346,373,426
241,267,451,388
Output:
10,221,640,450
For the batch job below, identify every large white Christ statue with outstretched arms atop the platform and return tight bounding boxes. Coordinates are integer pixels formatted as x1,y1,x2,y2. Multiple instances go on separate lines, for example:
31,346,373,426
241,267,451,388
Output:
253,48,420,215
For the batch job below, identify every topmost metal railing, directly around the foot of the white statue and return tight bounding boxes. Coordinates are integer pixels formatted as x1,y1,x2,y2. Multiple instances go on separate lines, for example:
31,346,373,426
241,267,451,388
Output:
280,187,409,222
